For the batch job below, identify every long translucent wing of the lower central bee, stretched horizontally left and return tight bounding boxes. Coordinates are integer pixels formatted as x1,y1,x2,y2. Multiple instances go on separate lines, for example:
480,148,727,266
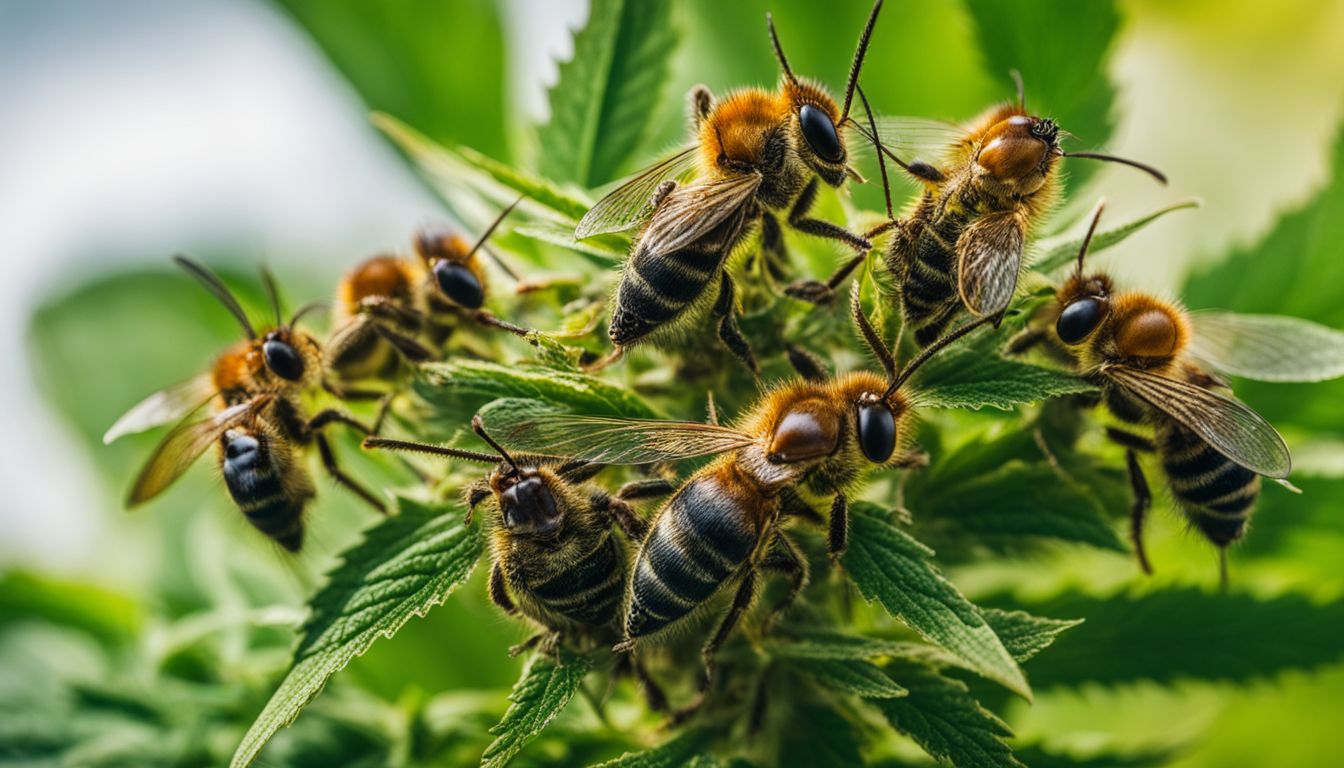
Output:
489,413,754,464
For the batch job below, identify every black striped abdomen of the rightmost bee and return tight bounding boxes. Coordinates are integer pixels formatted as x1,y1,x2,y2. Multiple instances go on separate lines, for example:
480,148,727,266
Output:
1157,422,1261,546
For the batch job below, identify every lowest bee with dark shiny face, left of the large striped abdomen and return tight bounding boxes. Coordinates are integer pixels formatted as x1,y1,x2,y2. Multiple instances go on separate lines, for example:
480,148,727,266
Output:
364,416,673,709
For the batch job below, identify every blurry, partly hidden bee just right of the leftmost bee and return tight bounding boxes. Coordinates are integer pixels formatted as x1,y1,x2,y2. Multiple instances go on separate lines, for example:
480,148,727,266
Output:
327,198,528,382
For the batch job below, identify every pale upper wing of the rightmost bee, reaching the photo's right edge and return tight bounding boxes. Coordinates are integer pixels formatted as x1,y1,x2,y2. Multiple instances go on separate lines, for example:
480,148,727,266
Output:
1191,311,1344,382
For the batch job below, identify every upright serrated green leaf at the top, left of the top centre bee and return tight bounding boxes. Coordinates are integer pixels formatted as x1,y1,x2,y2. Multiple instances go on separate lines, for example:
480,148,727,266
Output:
539,0,676,188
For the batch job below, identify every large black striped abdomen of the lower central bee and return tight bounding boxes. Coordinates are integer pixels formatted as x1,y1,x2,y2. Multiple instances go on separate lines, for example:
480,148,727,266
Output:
625,473,761,639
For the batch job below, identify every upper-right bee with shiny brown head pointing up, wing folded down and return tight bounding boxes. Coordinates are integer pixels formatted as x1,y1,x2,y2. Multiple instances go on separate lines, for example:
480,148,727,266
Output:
868,73,1167,346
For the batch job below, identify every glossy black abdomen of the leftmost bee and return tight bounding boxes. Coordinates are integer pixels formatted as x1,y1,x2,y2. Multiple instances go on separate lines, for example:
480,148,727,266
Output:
223,433,312,551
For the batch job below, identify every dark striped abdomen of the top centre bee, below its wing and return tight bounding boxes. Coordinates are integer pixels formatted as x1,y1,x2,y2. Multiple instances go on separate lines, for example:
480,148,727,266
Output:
607,208,746,346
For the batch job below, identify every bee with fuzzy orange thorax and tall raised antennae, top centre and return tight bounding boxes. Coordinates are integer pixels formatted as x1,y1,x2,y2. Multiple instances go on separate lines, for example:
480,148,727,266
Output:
574,0,882,371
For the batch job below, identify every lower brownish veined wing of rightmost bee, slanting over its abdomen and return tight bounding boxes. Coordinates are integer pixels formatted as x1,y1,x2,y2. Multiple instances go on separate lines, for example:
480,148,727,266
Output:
1102,366,1293,479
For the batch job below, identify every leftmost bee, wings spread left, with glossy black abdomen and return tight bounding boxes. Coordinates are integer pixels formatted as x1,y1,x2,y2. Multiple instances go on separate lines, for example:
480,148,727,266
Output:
103,256,383,551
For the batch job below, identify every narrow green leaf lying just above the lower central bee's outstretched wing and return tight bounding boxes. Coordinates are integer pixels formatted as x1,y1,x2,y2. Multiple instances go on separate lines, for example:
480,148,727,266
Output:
415,359,659,418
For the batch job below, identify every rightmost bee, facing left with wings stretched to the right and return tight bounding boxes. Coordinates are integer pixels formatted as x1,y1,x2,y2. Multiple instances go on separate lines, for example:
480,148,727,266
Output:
1008,206,1344,584
